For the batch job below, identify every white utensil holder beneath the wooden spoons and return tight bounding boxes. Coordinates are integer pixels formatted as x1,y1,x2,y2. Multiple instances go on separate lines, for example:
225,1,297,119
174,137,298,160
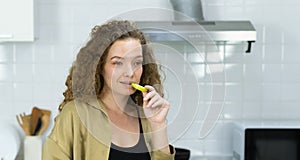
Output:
24,136,42,160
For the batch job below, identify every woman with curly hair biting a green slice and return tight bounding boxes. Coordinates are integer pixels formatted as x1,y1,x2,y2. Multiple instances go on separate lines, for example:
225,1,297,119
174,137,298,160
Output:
43,21,175,160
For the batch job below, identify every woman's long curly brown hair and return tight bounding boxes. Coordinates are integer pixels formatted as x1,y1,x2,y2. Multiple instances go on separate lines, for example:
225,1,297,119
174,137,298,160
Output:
58,20,163,111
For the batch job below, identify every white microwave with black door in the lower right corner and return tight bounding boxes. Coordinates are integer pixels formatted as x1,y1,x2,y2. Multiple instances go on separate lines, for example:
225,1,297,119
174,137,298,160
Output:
232,121,300,160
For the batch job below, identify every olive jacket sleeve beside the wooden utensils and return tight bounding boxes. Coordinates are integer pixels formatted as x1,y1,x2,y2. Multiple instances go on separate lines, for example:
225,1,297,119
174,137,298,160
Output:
42,103,74,160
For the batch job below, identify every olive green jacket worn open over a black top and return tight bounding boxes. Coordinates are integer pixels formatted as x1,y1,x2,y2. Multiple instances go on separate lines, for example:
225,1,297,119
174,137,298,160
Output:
43,99,175,160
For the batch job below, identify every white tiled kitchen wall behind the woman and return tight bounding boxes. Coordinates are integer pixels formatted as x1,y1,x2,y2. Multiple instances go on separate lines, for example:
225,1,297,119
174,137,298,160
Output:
0,0,300,159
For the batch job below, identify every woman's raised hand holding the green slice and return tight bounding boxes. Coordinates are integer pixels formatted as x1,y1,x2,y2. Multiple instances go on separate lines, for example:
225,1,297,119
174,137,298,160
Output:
143,85,170,126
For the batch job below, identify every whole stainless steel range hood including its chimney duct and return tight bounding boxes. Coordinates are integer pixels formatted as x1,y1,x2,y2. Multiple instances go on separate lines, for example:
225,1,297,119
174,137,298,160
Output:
136,0,256,53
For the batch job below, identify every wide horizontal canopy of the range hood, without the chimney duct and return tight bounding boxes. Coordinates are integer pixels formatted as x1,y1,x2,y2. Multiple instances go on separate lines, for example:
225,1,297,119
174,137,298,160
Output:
136,21,256,53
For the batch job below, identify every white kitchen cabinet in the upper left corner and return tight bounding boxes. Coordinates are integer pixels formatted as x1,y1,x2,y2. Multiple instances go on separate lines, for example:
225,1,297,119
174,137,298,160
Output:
0,0,34,42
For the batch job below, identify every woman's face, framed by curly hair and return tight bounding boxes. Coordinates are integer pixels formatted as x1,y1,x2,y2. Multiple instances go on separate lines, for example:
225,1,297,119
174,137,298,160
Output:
103,38,143,95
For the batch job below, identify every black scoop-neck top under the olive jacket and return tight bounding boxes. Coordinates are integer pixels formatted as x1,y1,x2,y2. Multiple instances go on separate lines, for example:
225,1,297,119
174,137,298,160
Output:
108,118,151,160
